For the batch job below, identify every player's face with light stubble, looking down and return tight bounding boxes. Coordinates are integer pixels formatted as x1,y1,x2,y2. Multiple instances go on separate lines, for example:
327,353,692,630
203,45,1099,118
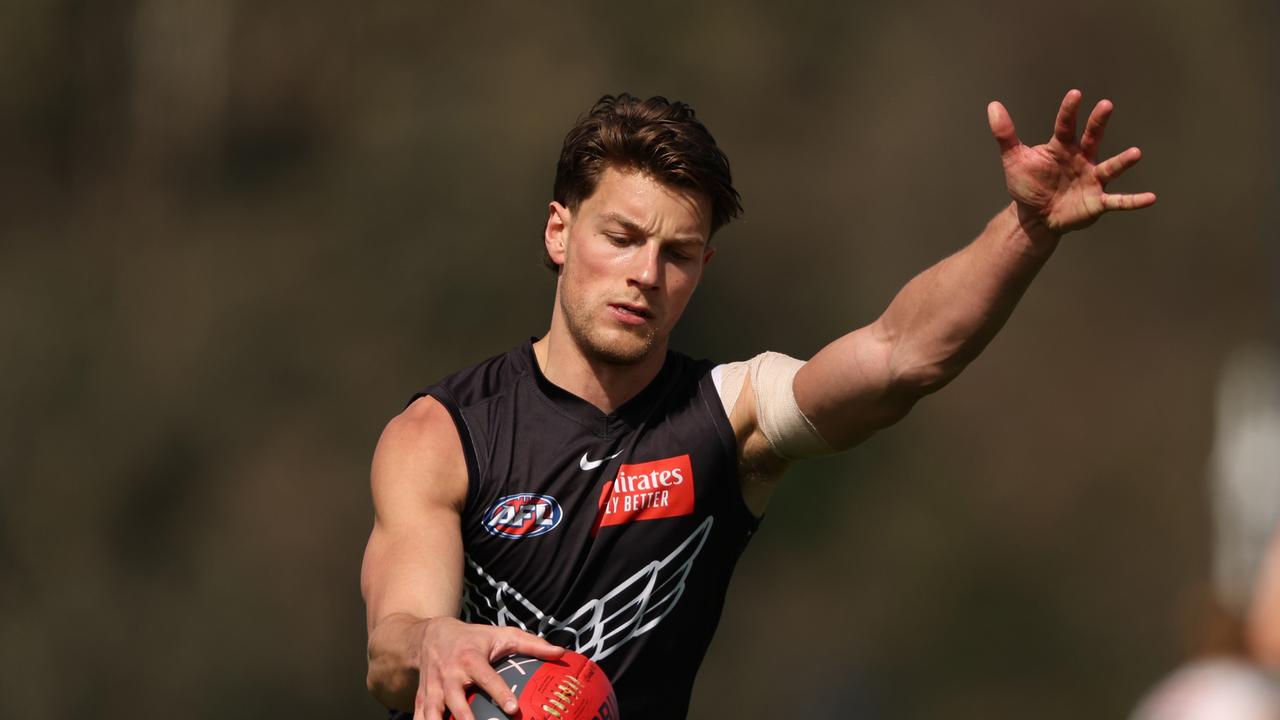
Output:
547,168,713,364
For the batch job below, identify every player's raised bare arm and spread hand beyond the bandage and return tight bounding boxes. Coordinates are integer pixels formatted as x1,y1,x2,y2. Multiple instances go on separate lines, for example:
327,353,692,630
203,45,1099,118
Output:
794,90,1156,450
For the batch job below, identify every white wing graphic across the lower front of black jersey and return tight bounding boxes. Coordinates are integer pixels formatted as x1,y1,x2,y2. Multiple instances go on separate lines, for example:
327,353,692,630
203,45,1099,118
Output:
462,516,716,662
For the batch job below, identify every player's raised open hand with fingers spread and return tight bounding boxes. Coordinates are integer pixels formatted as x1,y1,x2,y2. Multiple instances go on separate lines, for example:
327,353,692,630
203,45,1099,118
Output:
987,90,1156,236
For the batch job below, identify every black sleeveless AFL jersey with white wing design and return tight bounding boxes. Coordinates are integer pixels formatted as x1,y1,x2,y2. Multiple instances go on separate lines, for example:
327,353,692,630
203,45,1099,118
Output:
404,342,756,720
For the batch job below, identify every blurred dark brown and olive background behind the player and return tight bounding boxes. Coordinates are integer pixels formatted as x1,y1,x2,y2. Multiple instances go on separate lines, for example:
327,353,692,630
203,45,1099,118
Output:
0,0,1280,719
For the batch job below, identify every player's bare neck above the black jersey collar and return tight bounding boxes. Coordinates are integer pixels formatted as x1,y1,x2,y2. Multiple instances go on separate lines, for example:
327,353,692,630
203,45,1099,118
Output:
534,320,667,414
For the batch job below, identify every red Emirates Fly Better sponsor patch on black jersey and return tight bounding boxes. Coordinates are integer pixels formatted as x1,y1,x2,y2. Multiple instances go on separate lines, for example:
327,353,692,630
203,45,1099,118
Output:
595,455,694,529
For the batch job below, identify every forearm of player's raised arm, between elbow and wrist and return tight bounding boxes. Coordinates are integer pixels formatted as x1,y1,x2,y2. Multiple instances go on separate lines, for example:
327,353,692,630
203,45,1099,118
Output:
877,202,1059,395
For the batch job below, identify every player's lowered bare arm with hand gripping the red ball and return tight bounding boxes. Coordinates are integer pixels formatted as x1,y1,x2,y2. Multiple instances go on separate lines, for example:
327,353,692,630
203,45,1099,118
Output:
360,397,563,720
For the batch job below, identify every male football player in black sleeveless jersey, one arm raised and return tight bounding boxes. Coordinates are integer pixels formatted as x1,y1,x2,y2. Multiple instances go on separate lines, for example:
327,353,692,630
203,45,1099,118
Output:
361,90,1156,720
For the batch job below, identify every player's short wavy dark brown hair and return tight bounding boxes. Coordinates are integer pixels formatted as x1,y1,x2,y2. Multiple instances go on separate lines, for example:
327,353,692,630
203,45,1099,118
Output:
543,92,742,270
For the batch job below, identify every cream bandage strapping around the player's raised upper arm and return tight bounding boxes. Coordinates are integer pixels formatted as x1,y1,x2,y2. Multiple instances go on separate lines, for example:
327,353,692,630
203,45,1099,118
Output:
712,352,835,460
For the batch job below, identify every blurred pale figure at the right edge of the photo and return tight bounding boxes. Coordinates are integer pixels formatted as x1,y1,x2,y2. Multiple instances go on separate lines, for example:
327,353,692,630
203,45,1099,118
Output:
1134,347,1280,720
